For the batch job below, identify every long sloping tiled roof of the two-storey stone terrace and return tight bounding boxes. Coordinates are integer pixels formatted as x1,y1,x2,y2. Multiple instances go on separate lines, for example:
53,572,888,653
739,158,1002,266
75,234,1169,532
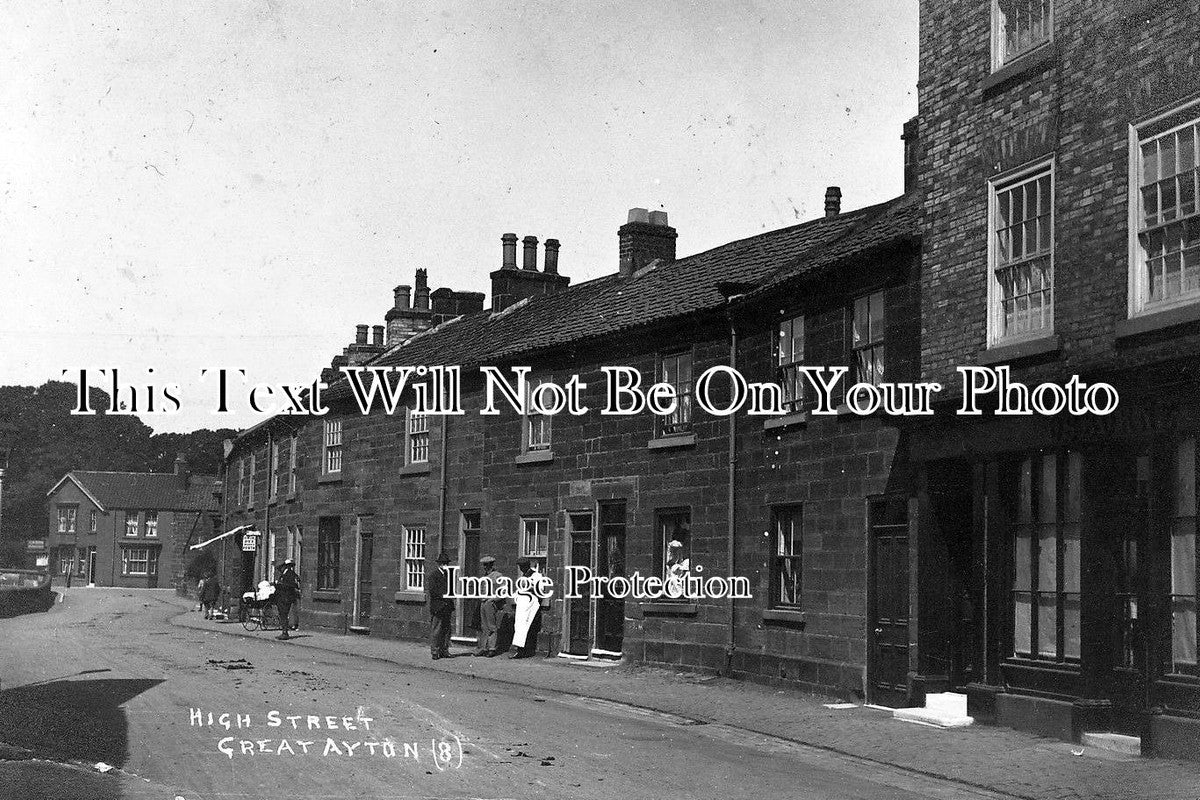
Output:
326,194,919,399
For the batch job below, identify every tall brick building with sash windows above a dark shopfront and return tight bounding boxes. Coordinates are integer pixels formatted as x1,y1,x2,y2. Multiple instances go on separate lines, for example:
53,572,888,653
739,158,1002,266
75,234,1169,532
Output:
906,0,1200,756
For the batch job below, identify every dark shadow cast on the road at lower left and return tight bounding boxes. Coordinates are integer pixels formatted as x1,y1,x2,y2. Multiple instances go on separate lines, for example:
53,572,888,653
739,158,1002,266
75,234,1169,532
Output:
0,678,162,766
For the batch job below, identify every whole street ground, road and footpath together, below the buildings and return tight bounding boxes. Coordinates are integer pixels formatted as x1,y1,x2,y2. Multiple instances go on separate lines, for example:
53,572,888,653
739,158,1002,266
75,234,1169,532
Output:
0,589,1200,800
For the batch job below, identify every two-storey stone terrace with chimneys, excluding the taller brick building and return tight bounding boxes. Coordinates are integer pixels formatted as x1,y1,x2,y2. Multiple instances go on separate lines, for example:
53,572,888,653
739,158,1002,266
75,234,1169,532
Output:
218,183,920,703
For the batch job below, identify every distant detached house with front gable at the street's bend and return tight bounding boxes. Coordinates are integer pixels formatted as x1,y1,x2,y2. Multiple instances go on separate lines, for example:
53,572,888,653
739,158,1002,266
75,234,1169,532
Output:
47,457,221,589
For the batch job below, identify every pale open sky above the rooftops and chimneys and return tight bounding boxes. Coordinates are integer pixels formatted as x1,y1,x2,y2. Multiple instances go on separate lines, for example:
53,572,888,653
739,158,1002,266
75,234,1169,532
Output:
0,0,917,432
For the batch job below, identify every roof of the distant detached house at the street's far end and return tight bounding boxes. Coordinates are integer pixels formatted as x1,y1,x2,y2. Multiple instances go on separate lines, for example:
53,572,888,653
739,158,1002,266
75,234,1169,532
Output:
48,470,221,511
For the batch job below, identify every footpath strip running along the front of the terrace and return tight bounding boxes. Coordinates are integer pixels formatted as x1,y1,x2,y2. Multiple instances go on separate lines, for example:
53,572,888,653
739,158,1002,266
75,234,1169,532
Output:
173,599,1200,800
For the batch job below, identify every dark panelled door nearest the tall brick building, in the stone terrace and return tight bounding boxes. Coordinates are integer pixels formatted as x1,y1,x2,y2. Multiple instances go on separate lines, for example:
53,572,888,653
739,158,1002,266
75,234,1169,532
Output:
866,495,908,708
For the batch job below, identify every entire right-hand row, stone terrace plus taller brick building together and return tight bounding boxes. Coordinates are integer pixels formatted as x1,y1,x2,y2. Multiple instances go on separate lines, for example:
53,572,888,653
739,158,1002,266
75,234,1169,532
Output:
189,0,1200,756
